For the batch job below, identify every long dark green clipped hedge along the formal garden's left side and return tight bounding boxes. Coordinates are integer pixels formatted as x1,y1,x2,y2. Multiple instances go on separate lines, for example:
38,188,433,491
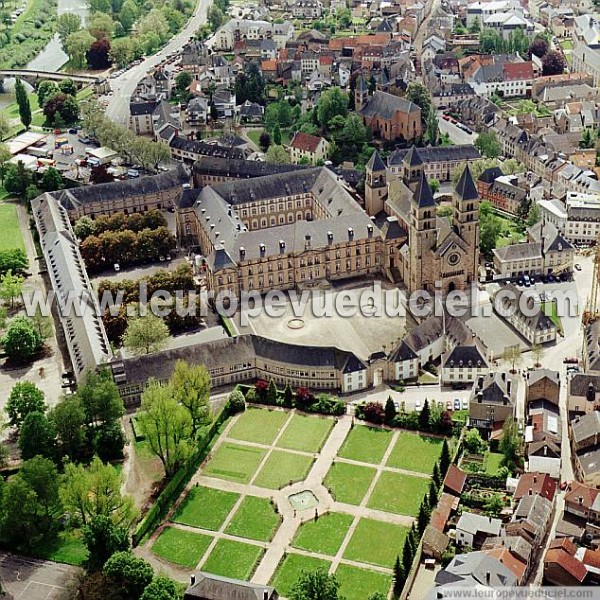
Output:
131,405,229,546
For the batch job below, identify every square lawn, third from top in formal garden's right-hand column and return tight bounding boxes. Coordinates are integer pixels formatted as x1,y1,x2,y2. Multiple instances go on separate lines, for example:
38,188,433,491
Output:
344,519,408,569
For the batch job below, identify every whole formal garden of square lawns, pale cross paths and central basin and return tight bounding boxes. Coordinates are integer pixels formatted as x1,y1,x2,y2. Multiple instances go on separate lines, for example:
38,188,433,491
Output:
147,408,442,600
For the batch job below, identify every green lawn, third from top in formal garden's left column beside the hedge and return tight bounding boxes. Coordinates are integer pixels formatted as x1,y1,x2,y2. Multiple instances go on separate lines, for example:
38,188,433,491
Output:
173,487,240,531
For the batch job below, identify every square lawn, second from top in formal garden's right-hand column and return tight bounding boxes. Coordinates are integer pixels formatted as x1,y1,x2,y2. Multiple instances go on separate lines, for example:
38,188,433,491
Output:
367,471,430,517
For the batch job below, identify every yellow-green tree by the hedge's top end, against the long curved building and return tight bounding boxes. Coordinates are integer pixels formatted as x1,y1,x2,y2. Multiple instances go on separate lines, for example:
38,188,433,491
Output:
170,360,211,438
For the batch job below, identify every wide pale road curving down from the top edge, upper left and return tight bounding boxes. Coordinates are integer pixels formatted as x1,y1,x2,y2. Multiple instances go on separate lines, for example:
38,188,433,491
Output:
106,0,210,124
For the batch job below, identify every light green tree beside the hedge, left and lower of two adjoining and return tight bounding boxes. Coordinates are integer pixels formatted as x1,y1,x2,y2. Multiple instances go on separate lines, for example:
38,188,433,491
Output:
139,381,192,478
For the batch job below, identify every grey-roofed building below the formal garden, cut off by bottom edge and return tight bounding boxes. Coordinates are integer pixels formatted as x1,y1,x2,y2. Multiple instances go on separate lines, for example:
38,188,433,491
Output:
183,573,279,600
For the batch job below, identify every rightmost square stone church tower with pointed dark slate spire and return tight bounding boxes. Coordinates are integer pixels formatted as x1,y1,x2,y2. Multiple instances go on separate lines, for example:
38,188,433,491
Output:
452,165,479,283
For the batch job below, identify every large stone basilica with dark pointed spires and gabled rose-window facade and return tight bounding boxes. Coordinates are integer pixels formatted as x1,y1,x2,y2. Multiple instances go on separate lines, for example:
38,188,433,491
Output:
365,146,479,295
